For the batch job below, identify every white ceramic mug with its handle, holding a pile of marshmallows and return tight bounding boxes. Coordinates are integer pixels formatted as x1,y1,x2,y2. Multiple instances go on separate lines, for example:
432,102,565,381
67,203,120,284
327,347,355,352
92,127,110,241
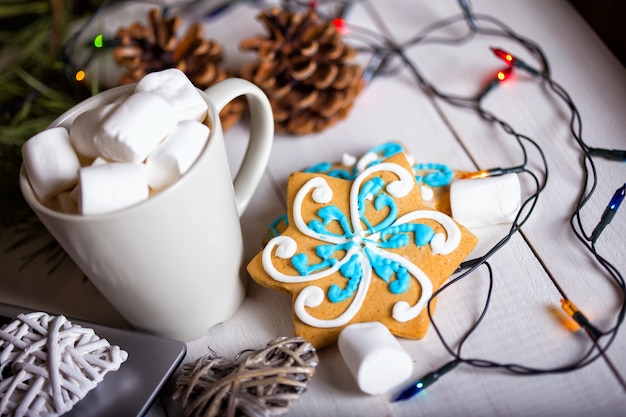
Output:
20,78,274,341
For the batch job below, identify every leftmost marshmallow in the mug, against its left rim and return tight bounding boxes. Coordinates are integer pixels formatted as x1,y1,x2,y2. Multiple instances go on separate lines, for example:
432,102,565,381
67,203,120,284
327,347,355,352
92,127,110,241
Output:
22,127,80,202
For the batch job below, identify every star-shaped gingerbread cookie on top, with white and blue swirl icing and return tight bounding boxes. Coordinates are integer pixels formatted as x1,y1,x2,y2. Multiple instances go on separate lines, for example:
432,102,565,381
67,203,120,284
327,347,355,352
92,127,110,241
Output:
248,153,477,348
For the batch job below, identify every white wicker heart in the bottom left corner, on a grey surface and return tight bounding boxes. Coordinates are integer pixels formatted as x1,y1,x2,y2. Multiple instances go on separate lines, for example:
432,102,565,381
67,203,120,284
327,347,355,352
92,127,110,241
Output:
0,312,128,416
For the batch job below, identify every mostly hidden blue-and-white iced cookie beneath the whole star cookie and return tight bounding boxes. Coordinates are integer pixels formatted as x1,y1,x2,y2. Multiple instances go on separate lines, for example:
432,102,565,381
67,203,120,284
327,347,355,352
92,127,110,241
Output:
263,142,467,245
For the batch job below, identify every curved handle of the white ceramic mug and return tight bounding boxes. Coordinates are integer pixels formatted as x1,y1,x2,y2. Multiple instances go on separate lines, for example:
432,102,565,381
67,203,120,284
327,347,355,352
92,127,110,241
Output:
204,78,274,217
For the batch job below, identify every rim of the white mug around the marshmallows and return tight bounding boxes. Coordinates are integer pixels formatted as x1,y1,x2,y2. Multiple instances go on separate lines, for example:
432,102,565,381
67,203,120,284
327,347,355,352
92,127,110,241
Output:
19,83,223,221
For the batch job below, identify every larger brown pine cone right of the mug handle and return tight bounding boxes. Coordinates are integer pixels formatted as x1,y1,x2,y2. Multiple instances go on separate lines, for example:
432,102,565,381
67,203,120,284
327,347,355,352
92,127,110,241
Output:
240,8,361,135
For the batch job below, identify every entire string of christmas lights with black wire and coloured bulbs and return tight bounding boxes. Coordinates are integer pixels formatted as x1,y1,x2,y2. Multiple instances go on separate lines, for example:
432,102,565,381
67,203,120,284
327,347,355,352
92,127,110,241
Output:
58,0,626,400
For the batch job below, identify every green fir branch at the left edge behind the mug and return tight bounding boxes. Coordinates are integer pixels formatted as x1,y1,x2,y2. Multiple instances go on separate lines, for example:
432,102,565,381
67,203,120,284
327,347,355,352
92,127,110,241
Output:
0,0,100,269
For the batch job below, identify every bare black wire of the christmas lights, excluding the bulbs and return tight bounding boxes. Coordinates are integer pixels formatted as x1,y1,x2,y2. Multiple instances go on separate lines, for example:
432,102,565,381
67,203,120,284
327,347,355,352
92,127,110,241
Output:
330,1,626,382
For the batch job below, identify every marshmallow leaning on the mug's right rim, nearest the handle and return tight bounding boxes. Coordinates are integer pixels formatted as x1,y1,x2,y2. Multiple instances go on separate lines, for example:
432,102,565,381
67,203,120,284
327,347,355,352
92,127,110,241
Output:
146,120,210,191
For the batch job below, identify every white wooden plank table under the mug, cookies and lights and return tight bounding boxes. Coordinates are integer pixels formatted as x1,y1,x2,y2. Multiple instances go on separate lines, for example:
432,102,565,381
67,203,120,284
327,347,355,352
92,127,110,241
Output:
0,0,626,416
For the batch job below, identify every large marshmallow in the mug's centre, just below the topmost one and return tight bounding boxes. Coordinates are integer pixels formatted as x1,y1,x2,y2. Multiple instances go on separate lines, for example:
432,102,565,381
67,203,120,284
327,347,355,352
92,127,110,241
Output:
94,93,176,163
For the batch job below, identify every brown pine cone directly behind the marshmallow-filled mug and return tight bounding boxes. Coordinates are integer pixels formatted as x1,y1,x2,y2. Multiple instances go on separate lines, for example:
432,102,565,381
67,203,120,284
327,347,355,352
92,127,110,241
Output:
113,9,245,129
